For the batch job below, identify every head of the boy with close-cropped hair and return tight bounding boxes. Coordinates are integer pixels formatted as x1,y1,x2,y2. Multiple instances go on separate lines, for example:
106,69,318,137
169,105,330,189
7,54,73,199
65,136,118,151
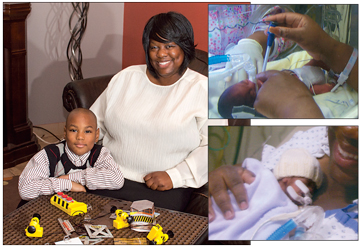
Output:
64,108,99,155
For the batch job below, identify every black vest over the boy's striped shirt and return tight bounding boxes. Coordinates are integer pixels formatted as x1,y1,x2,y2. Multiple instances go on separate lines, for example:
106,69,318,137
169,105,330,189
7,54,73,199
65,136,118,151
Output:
44,141,102,177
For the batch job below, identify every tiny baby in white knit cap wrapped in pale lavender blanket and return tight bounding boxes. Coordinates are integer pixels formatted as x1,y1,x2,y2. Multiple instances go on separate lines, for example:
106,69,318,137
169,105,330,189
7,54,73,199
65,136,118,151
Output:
209,149,323,240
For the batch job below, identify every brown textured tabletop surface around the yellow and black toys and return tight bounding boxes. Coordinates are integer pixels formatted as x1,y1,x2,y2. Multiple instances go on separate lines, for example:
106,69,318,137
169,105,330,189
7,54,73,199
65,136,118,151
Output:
3,192,208,245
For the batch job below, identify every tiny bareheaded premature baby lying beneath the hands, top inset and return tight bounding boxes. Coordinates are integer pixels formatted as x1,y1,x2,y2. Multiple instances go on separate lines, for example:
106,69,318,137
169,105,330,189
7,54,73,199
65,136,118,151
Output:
218,65,335,119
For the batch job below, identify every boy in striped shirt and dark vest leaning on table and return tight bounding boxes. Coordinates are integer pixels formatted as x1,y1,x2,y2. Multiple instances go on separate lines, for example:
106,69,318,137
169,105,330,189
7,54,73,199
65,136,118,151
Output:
19,108,124,201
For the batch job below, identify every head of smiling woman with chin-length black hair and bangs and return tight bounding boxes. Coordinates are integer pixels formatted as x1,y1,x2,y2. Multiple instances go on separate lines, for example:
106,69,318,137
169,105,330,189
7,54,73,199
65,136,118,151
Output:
142,12,195,85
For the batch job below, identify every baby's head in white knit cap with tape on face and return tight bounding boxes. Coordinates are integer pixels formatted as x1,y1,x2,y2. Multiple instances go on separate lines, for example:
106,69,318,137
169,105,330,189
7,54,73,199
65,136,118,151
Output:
273,148,323,205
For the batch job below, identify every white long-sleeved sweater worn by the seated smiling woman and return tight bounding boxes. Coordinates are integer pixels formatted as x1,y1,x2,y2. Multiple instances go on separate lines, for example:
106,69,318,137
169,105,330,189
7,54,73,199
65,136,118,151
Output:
90,65,208,188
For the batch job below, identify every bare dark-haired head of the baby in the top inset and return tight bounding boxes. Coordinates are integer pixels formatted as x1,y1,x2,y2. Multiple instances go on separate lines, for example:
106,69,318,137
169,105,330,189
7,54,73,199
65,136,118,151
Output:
218,79,261,119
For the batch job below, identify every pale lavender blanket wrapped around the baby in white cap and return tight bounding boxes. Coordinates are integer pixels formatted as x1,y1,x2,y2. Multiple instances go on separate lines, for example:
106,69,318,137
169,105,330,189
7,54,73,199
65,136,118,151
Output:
209,158,298,240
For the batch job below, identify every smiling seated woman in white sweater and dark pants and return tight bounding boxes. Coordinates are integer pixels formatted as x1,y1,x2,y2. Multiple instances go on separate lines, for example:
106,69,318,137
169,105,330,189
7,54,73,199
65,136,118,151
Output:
90,12,207,211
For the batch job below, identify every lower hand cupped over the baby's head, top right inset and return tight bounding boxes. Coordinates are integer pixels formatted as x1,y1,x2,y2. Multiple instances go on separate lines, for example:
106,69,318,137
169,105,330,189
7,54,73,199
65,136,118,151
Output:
254,70,324,118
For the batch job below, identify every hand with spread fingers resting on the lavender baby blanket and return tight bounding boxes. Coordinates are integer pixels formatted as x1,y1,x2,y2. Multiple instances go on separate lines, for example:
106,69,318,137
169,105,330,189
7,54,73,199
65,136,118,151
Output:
209,164,255,222
